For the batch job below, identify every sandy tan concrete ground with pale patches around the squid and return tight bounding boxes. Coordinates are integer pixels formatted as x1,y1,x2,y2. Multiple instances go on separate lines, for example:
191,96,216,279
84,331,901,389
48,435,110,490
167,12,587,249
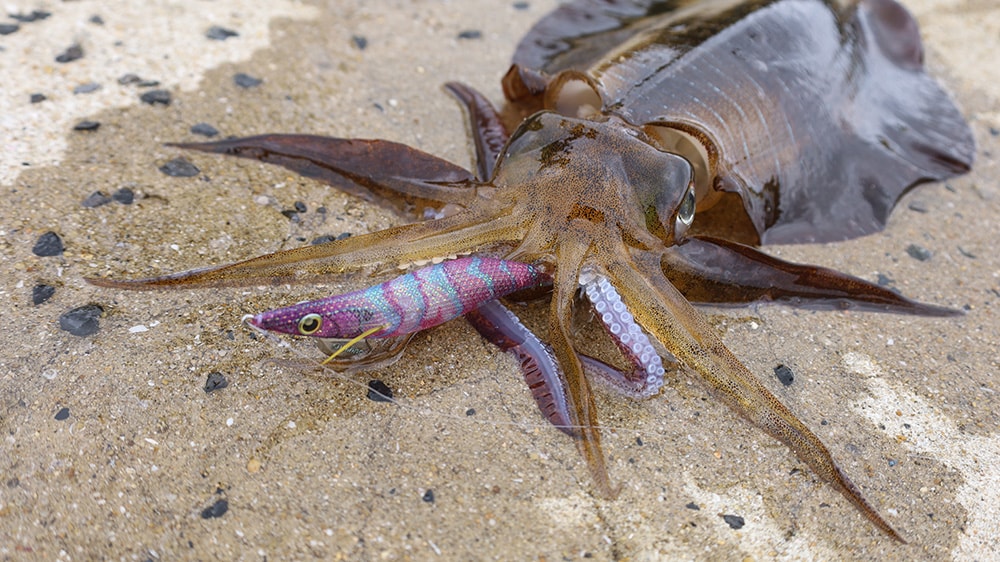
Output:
0,0,1000,560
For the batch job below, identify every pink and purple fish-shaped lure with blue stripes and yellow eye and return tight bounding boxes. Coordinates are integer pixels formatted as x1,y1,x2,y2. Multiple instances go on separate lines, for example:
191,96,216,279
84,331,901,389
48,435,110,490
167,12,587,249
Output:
249,257,549,339
